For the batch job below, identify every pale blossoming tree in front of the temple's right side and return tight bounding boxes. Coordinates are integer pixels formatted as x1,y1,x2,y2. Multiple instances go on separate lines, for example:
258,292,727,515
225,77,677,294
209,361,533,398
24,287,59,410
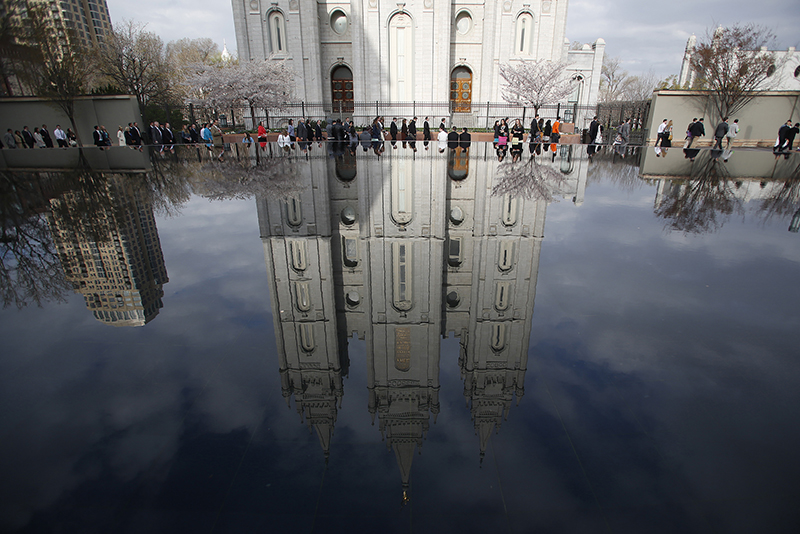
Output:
500,59,574,113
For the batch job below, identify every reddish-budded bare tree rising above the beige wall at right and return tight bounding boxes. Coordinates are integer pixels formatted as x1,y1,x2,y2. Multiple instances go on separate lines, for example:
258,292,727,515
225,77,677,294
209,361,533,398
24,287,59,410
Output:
690,24,780,117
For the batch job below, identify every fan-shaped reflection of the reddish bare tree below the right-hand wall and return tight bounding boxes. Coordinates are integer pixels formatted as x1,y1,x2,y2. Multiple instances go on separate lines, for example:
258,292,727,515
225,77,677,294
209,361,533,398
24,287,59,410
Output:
655,153,744,234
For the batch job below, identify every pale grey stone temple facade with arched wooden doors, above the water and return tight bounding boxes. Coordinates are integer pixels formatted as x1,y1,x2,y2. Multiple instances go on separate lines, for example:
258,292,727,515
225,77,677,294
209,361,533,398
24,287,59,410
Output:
232,0,605,120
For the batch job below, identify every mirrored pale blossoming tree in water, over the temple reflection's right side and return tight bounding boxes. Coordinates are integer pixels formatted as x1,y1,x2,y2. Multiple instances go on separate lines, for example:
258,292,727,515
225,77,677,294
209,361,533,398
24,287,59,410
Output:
492,157,566,202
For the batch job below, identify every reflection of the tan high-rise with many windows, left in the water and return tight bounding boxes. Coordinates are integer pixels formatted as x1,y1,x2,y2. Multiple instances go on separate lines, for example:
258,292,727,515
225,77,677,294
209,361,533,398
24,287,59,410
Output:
48,174,168,326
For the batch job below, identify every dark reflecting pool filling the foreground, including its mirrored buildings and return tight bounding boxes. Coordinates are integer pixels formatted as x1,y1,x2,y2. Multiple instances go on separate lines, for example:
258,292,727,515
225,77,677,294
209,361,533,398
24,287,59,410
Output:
0,143,800,533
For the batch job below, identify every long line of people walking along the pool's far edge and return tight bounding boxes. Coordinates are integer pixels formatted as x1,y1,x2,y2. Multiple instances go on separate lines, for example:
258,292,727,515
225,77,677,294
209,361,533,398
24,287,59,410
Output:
0,114,800,161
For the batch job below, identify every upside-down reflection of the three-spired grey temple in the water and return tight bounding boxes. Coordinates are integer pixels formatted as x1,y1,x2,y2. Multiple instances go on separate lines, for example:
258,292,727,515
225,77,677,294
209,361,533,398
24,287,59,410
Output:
257,146,587,497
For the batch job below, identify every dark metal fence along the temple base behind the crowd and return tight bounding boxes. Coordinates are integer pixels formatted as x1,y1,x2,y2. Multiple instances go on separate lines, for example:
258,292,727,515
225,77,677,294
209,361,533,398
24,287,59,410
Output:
192,101,650,137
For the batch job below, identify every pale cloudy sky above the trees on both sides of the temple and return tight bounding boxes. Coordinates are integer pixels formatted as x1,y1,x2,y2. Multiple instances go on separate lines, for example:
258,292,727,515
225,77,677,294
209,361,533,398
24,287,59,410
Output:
107,0,800,78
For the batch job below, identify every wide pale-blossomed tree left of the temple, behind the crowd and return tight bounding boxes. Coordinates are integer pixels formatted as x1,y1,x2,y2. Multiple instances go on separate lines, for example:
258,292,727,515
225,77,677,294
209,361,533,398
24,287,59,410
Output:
185,61,294,126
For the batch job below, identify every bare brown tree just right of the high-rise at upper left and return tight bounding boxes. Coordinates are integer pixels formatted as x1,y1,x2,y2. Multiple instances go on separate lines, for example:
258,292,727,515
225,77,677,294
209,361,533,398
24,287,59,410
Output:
97,21,173,114
